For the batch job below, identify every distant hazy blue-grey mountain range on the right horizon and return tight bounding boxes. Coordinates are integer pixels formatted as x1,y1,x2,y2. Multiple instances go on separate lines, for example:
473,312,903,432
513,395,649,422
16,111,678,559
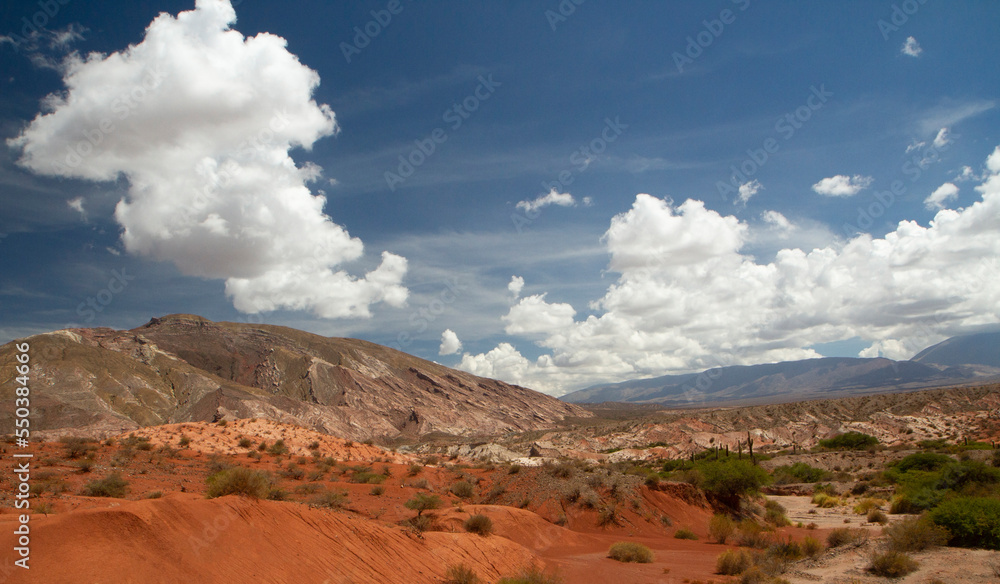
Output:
561,332,1000,407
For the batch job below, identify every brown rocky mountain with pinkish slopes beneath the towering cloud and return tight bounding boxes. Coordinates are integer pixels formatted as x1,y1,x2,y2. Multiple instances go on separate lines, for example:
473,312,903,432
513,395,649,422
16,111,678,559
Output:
0,314,591,440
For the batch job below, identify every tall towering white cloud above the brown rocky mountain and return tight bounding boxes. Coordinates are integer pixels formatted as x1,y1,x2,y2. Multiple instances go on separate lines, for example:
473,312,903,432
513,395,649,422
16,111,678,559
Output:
9,0,407,318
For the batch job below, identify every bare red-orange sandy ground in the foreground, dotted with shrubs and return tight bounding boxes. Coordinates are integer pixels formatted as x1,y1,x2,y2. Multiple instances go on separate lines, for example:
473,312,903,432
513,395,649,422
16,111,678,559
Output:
0,420,815,584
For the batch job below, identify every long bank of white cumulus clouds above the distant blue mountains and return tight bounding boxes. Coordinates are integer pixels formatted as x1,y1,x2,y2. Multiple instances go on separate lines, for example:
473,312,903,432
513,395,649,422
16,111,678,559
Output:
461,148,1000,394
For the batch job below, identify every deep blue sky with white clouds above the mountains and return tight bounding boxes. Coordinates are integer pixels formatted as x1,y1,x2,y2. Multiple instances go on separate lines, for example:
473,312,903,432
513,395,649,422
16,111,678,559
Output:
0,0,1000,394
